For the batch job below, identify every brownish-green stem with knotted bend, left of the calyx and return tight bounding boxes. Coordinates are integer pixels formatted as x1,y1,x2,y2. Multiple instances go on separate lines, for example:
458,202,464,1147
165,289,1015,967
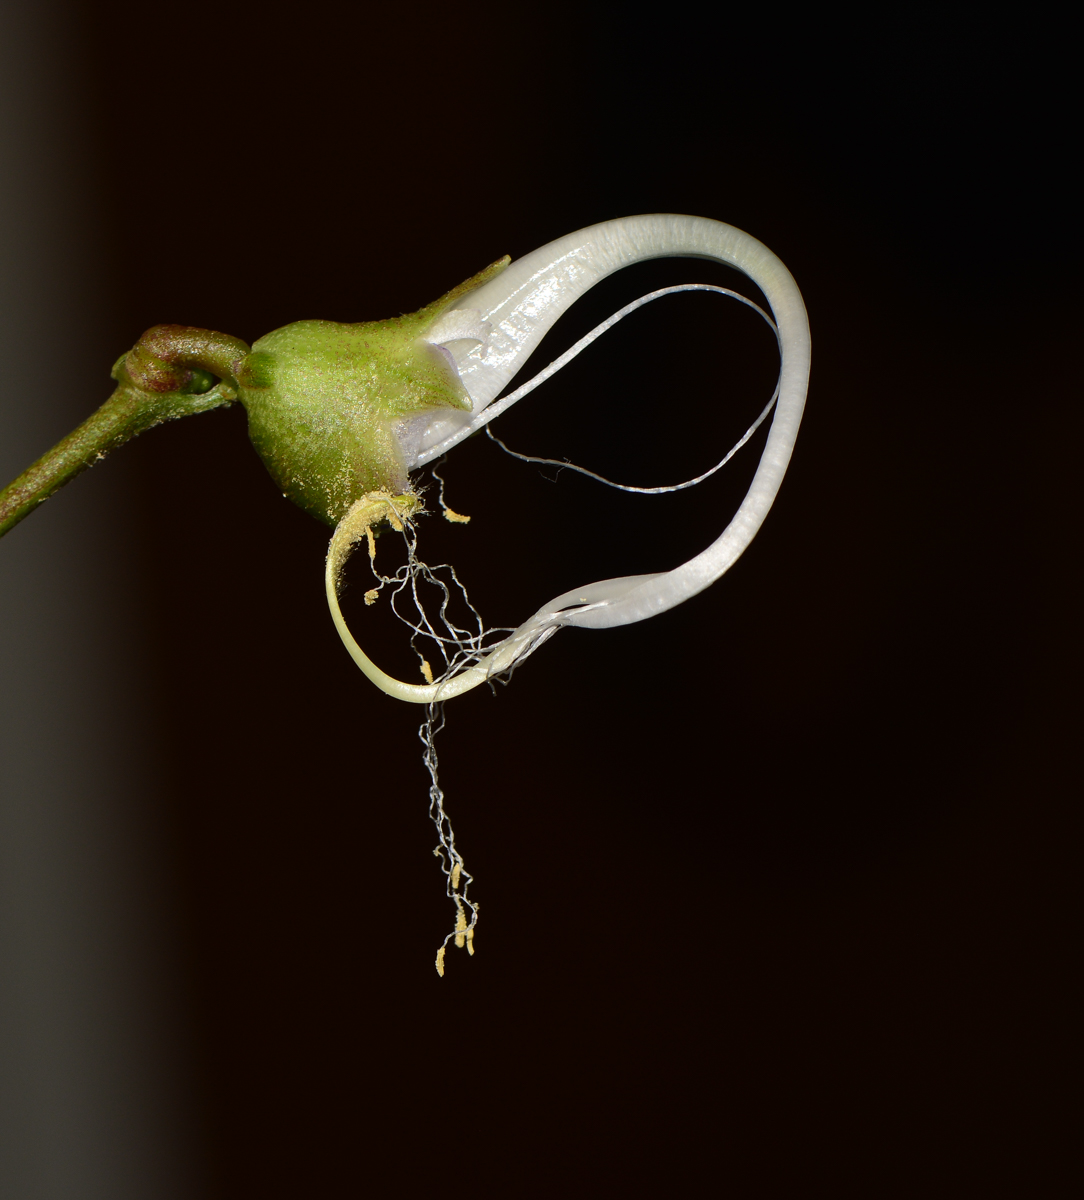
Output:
0,325,248,538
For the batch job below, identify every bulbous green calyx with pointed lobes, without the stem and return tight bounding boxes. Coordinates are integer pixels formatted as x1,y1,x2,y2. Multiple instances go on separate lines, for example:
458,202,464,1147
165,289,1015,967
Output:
236,258,509,526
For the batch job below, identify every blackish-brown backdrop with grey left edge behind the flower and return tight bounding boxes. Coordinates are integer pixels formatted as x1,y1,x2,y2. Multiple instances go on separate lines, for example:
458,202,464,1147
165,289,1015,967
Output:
0,0,1079,1200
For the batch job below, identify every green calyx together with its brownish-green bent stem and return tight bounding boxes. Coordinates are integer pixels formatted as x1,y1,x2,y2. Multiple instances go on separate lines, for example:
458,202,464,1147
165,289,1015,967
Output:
0,258,509,536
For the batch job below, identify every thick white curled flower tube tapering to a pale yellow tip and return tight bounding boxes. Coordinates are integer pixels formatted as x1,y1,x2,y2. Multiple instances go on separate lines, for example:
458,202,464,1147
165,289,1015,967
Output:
325,214,810,704
